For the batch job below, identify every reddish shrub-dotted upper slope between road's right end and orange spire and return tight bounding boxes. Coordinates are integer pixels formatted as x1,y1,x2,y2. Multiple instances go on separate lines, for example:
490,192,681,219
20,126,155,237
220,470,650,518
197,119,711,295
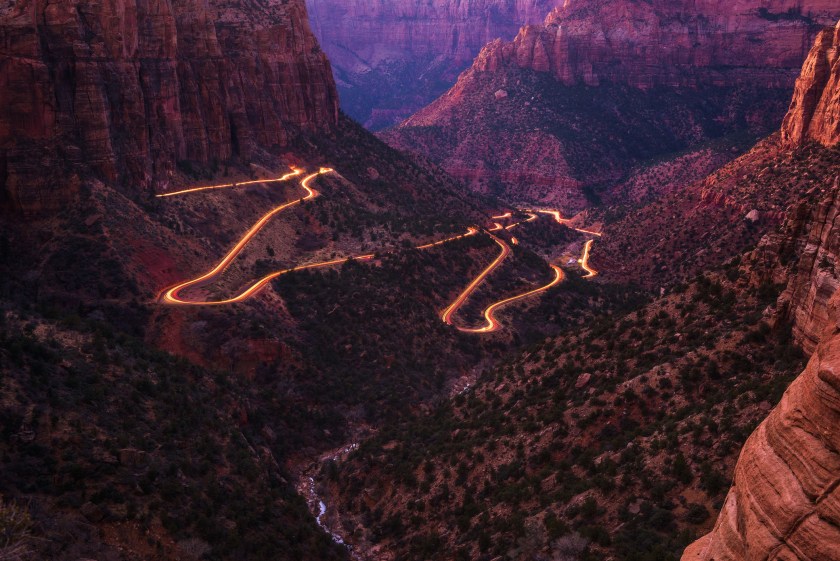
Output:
590,134,840,288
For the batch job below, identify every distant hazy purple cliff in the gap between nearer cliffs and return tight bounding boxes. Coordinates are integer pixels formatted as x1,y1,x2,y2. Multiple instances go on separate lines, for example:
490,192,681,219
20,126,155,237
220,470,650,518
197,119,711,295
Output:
307,0,561,128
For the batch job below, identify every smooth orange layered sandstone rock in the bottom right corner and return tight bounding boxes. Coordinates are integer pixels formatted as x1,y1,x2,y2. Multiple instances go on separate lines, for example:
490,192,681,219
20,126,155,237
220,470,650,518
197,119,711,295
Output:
683,299,840,561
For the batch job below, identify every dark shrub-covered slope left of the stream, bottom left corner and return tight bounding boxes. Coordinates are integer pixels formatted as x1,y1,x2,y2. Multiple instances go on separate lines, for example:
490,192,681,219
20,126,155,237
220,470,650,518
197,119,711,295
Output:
0,308,347,561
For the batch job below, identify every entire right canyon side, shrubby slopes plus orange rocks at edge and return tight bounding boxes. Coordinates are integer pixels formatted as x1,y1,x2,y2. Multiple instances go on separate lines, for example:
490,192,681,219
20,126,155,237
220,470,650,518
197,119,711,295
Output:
319,19,840,561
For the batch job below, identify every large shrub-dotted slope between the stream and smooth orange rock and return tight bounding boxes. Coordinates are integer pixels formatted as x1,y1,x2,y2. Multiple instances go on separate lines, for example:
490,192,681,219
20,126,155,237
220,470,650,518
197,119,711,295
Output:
322,233,802,559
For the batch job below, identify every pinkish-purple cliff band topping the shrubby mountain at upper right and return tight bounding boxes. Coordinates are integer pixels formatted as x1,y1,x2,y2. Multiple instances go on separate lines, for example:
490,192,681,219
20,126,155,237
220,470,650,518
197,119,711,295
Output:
475,0,840,89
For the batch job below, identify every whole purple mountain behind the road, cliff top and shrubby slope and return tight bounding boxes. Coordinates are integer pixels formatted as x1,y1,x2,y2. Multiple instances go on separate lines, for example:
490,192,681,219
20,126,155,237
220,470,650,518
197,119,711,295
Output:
383,1,840,206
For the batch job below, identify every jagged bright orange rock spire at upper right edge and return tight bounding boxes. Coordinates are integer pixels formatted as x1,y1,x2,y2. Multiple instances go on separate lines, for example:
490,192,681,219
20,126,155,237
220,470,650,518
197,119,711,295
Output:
782,22,840,146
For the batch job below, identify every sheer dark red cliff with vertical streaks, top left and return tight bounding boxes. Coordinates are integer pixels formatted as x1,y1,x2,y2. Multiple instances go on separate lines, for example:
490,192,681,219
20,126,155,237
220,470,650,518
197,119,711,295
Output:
0,0,338,210
